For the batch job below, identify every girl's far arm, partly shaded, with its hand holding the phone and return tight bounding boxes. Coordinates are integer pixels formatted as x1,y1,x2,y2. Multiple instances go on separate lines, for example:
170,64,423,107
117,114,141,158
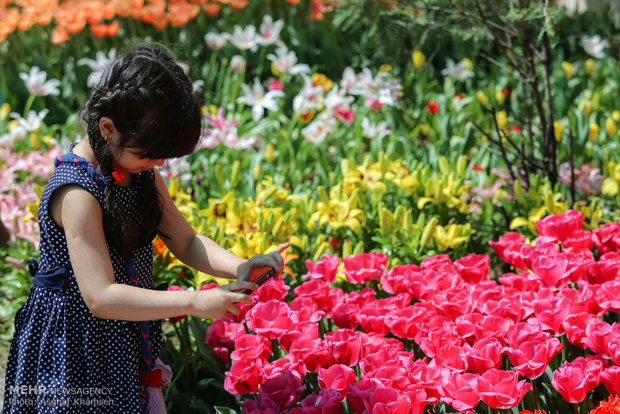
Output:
154,169,284,280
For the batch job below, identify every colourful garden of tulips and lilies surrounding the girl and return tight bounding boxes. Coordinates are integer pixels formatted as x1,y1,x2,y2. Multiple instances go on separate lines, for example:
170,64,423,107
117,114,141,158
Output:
0,0,620,414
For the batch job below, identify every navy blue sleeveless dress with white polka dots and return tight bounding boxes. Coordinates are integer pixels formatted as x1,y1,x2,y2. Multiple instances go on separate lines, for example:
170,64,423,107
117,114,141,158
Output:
3,152,162,414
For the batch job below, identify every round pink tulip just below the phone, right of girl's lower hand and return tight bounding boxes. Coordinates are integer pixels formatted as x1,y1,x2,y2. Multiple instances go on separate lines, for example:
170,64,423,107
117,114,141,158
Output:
245,300,293,339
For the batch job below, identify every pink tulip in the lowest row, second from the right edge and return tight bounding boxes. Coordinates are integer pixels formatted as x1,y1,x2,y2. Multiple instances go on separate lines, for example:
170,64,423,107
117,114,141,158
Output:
551,356,604,404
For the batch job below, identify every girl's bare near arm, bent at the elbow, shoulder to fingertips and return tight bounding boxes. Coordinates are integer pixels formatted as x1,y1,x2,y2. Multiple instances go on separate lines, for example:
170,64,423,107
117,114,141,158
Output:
55,185,256,321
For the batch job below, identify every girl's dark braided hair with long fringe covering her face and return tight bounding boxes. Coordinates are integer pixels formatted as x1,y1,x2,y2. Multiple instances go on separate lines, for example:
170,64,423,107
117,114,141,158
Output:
80,43,201,256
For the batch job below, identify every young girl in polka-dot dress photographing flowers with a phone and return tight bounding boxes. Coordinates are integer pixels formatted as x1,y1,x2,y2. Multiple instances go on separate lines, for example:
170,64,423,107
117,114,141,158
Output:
4,44,285,413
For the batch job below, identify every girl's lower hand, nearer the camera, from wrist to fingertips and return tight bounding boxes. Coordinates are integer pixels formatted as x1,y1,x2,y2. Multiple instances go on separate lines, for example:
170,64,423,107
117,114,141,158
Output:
191,282,258,319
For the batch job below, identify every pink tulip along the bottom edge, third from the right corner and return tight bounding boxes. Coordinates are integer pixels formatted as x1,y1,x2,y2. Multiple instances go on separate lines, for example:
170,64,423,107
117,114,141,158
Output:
473,369,532,410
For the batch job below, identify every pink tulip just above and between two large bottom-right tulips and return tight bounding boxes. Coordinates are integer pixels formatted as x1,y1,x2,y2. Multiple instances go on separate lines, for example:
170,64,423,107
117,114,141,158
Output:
508,338,564,379
